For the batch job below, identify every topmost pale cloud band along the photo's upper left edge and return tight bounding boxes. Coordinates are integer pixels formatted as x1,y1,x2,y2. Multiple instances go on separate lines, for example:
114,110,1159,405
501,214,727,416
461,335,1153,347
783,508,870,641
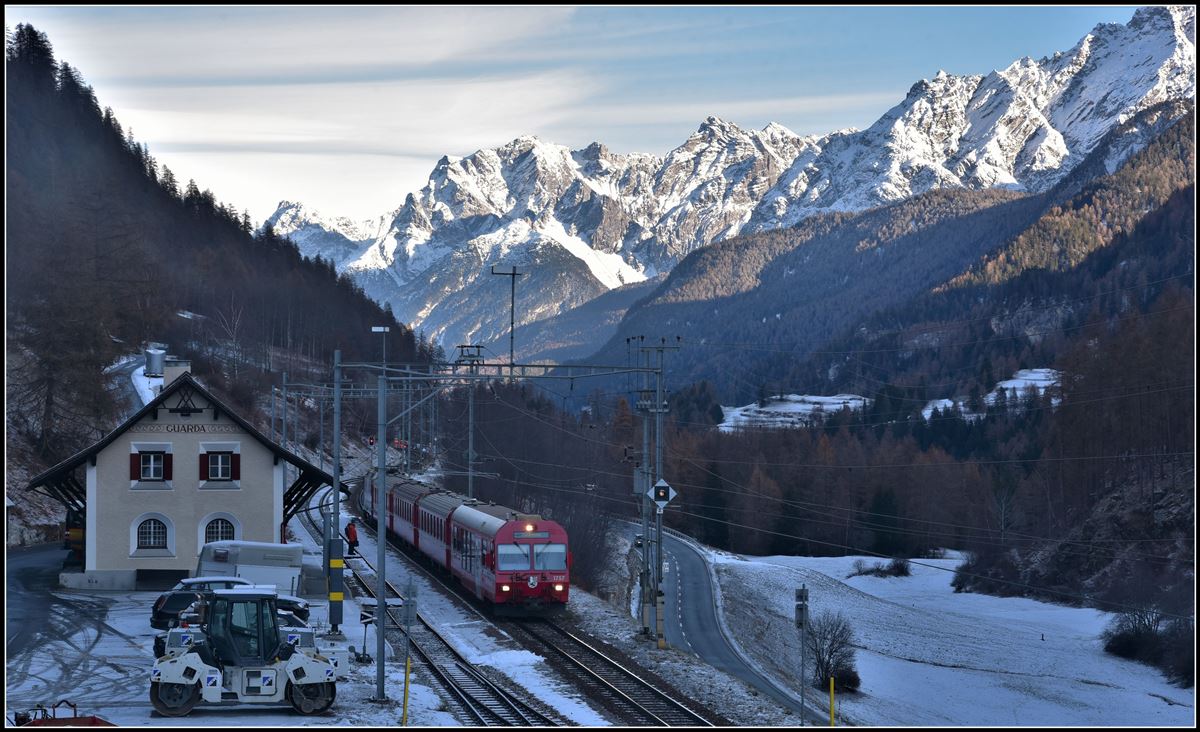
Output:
10,7,576,85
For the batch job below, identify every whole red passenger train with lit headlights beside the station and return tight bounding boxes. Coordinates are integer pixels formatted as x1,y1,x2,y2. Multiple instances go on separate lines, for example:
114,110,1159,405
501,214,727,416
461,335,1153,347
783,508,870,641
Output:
364,478,571,613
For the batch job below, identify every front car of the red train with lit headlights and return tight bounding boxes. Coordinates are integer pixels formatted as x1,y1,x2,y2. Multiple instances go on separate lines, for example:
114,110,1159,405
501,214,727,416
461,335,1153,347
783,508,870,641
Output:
451,500,571,614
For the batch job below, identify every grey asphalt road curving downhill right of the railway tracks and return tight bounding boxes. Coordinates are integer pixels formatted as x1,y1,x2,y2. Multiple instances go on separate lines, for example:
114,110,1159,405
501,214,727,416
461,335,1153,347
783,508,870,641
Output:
628,524,816,721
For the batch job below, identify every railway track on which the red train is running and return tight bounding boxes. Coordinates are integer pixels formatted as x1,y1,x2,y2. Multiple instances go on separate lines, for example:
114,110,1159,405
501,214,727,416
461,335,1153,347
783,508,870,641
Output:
354,472,714,727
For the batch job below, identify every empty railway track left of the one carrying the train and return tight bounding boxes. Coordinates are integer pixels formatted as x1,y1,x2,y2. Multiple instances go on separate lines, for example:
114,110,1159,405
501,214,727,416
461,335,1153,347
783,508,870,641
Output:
306,482,566,727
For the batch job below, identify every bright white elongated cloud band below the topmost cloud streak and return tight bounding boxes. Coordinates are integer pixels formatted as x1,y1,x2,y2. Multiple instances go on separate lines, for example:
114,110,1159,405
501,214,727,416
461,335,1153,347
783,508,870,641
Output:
109,71,602,160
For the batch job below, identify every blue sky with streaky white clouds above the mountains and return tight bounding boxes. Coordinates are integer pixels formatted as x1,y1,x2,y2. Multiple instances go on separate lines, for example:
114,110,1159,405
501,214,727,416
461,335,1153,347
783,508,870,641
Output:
5,6,1135,221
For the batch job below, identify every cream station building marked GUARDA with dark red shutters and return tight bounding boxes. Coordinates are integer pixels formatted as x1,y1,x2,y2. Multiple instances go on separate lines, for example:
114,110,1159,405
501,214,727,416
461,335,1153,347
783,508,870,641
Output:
29,371,334,589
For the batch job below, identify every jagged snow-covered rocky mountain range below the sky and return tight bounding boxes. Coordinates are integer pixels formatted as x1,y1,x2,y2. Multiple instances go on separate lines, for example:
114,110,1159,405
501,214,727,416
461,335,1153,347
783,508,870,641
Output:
272,6,1195,342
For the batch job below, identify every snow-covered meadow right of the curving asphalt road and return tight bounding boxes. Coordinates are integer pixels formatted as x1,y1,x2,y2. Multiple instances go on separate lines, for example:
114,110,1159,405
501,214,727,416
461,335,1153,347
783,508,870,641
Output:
710,552,1195,726
